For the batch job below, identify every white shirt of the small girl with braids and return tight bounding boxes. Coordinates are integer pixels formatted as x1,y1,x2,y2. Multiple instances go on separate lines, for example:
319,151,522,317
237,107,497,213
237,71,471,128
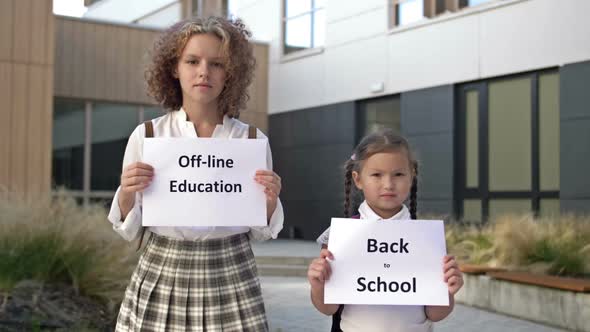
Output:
317,201,432,332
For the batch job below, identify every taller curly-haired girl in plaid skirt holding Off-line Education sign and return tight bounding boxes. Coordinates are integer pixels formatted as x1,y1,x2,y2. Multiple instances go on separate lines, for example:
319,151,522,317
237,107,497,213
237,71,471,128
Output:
108,17,283,331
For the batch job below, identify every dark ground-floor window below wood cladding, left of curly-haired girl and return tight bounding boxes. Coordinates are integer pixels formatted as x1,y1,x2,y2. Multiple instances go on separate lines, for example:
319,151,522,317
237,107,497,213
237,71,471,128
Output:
52,98,164,203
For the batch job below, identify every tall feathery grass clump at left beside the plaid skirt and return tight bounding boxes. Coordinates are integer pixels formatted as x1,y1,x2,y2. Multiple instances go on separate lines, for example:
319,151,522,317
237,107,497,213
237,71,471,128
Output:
0,192,138,305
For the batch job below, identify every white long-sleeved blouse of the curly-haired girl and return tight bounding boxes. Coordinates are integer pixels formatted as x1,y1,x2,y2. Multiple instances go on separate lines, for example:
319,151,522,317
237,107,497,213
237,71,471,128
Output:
108,108,284,241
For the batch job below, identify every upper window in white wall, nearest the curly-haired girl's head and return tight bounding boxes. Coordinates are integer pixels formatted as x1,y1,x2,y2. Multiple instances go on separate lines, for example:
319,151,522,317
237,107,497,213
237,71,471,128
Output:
283,0,326,54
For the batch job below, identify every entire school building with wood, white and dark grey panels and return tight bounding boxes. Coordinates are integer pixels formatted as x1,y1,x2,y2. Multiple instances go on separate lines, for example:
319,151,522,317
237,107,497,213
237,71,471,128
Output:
0,0,590,239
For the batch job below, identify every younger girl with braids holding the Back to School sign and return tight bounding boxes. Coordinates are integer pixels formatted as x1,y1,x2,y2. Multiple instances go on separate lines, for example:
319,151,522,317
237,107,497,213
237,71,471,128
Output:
307,130,463,332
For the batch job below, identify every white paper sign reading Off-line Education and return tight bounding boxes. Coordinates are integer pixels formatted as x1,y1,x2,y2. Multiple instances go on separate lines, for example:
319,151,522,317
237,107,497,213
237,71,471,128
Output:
142,137,267,226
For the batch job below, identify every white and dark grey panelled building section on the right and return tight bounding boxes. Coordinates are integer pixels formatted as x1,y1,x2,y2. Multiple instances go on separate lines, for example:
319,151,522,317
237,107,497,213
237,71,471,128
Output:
232,0,590,239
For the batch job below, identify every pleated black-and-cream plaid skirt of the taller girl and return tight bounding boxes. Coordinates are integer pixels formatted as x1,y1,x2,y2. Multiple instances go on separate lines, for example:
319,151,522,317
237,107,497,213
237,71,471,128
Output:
116,234,268,332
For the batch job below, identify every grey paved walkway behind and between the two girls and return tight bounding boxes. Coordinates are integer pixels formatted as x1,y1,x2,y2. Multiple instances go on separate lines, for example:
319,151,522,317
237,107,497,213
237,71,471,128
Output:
253,239,564,332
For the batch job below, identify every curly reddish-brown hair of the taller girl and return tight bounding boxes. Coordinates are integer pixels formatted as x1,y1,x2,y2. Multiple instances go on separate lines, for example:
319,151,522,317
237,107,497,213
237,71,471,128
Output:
145,16,256,118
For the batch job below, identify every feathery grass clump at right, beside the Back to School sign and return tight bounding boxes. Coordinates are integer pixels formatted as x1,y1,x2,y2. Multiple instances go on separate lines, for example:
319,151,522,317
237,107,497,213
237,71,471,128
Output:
446,214,590,277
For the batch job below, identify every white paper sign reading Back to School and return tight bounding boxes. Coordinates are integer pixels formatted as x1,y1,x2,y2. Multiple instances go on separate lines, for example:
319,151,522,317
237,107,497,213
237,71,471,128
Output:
324,218,449,305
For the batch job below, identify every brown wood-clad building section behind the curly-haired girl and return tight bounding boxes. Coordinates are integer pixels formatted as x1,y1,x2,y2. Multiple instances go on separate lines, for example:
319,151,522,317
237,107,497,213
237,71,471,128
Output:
0,0,268,203
